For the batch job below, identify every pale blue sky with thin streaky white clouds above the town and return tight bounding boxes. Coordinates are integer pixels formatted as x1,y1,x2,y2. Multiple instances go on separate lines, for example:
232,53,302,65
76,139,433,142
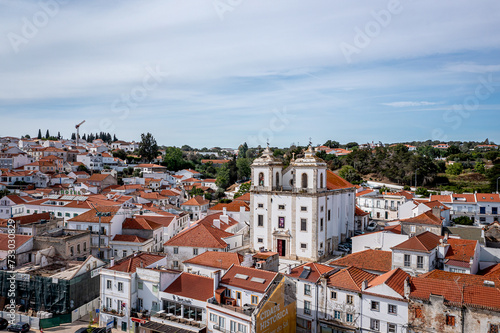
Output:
0,0,500,148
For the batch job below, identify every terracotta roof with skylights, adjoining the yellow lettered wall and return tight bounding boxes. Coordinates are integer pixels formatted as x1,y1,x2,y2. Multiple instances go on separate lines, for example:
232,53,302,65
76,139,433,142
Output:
220,265,278,293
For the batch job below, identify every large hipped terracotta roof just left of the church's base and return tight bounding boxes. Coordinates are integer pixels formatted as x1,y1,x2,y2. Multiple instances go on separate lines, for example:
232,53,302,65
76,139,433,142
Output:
164,219,234,249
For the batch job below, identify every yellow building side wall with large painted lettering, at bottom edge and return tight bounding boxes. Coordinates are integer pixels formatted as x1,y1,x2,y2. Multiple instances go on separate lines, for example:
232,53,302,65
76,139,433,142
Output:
256,279,297,333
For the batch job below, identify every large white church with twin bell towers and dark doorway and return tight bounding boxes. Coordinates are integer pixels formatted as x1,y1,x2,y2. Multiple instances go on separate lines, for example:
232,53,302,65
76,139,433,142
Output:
250,146,356,261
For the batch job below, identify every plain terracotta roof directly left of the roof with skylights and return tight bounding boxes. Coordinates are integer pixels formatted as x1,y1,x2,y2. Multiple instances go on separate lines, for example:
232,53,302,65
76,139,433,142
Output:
164,272,214,302
